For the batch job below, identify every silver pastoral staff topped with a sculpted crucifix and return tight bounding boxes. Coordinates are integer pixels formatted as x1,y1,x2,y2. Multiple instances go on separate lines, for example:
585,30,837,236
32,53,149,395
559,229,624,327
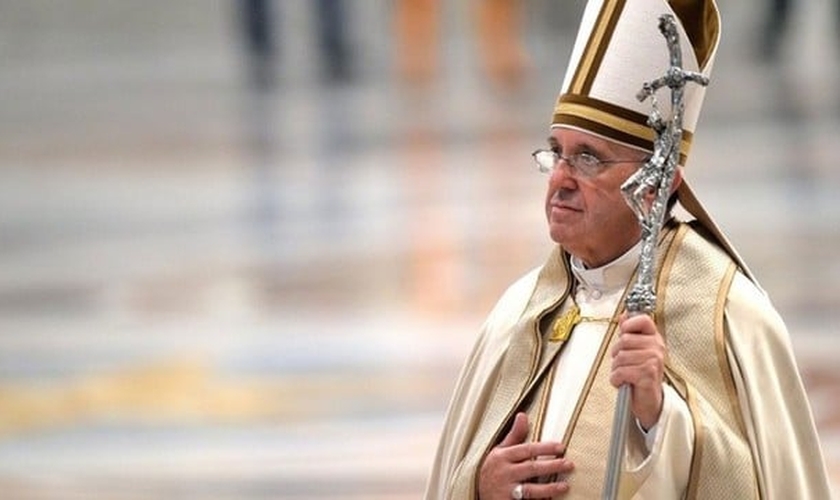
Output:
601,14,709,500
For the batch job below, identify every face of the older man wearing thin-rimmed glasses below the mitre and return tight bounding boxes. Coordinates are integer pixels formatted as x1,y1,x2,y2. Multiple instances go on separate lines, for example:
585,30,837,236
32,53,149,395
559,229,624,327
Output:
545,128,645,267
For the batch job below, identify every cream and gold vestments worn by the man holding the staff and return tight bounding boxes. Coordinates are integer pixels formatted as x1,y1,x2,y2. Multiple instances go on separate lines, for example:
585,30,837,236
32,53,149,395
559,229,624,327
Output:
426,224,830,500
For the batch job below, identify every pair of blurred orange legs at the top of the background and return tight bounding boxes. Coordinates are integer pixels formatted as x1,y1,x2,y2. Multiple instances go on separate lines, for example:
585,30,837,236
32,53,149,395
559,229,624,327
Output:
394,0,528,88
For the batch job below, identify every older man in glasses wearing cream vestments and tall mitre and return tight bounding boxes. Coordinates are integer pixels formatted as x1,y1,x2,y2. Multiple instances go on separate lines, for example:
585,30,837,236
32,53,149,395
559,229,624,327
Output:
426,0,830,500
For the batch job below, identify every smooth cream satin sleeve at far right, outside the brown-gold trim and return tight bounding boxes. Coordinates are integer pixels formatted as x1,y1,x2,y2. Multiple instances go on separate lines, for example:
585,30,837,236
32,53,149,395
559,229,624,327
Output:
725,274,831,499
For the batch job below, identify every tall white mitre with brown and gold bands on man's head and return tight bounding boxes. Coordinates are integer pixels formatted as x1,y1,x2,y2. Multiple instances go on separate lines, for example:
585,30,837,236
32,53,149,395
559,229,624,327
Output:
551,0,720,165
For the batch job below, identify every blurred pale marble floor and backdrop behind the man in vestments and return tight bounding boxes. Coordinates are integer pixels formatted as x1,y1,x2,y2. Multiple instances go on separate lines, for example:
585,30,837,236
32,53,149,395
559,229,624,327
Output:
0,0,840,500
